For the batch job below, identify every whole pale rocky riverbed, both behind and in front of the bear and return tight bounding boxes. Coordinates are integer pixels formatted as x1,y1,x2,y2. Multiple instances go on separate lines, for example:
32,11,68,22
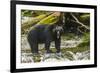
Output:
21,35,90,63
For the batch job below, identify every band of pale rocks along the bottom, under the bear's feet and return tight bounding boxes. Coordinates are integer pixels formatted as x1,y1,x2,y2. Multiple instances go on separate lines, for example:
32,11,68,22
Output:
21,51,90,63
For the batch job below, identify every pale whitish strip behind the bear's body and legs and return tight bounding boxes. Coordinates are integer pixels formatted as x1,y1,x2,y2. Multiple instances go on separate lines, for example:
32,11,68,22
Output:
21,35,82,50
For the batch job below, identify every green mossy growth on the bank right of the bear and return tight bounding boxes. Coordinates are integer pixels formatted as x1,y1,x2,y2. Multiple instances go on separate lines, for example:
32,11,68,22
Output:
62,32,90,53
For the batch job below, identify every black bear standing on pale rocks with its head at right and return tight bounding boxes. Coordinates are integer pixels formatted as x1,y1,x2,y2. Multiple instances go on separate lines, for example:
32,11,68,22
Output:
27,24,63,54
